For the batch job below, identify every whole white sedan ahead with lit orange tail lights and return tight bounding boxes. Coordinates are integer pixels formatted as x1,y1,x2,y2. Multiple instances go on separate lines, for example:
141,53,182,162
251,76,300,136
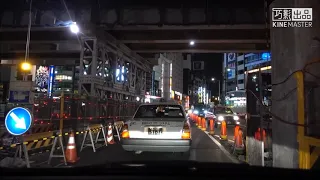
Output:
121,102,192,153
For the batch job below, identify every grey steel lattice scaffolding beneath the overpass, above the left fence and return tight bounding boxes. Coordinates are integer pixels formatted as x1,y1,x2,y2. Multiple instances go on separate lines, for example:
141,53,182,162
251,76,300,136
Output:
79,32,151,100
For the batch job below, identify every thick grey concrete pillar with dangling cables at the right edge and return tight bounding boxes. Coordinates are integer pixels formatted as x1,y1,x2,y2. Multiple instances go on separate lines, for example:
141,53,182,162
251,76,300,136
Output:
270,0,320,168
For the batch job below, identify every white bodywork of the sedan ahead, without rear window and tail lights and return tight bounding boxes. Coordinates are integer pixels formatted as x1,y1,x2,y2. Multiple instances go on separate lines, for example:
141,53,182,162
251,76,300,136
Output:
121,102,191,152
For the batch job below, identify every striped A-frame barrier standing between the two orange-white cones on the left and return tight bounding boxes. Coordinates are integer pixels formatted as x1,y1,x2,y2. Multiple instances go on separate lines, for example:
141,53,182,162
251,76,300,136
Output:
80,124,108,152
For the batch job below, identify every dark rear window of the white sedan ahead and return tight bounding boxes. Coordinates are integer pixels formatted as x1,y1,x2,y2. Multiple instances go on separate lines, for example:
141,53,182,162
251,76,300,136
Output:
134,105,184,118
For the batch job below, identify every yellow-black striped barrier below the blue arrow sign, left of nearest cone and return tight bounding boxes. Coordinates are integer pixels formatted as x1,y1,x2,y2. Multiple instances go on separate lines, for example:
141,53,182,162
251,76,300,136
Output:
14,132,64,168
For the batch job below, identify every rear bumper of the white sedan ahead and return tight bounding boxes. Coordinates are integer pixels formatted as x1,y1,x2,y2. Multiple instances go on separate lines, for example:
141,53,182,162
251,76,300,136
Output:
121,139,192,152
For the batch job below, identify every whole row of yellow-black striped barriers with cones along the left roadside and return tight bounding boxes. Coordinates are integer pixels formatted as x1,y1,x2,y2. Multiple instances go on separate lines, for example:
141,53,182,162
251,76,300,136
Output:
0,121,124,167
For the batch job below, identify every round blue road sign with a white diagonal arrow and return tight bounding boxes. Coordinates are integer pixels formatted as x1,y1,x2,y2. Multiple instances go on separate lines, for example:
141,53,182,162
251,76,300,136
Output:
5,107,32,136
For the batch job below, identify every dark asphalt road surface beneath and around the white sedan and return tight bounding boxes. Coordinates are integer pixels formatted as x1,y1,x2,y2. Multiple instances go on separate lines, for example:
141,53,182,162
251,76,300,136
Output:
31,126,238,168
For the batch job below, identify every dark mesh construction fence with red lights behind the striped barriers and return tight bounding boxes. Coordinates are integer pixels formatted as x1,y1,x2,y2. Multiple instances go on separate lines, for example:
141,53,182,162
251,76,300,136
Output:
0,96,140,165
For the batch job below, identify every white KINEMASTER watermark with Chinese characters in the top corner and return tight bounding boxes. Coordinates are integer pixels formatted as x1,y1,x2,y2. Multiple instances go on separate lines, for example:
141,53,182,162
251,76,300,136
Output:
272,8,312,28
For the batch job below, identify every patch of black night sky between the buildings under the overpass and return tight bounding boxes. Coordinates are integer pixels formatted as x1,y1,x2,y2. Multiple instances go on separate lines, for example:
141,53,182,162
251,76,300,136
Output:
193,53,223,96
